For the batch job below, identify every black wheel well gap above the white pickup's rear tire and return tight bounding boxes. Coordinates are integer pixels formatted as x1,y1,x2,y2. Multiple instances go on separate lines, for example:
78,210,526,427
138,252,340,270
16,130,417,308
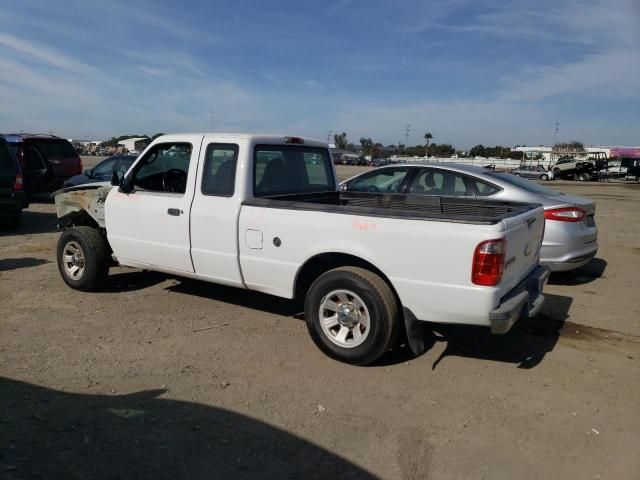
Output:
294,253,402,307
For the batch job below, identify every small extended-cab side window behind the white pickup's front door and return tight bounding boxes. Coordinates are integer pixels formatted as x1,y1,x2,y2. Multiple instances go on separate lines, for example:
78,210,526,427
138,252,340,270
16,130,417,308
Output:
201,143,238,197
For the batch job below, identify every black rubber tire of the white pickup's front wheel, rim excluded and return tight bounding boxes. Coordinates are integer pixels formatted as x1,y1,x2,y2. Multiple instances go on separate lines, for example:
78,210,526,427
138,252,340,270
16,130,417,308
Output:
57,226,110,292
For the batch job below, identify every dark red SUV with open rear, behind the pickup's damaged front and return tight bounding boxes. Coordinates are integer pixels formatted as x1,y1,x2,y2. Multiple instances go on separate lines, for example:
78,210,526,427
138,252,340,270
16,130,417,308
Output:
0,133,82,193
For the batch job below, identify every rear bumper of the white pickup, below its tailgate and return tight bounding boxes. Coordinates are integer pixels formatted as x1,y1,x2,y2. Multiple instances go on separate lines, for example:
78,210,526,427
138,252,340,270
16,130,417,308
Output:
489,266,550,334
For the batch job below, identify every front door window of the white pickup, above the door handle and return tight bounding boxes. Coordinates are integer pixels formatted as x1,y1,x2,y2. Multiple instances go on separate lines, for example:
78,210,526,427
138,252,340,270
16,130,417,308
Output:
133,143,193,193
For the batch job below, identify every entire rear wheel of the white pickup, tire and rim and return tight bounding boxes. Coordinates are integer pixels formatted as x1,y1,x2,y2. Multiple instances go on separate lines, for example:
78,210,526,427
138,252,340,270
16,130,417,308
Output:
305,267,399,365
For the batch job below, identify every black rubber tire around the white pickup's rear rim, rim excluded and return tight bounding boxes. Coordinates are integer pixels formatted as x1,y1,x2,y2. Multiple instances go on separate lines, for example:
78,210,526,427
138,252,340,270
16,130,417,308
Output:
304,267,399,365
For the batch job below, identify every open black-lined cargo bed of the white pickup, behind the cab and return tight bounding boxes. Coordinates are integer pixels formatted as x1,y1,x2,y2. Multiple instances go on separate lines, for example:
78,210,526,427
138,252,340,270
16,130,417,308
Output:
243,191,539,225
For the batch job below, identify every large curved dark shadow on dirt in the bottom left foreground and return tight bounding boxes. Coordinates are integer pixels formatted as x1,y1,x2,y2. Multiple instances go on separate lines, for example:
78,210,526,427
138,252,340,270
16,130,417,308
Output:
0,378,375,480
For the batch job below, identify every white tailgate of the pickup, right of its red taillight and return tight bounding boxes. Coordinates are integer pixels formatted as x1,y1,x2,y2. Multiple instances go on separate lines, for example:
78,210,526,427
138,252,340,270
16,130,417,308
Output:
500,206,544,291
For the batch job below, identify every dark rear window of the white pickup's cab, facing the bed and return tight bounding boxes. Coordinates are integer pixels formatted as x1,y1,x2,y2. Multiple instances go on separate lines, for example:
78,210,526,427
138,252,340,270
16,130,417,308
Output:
253,145,335,197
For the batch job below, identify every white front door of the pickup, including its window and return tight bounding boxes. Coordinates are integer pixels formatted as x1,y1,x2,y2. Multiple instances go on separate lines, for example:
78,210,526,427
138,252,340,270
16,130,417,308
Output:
105,139,202,273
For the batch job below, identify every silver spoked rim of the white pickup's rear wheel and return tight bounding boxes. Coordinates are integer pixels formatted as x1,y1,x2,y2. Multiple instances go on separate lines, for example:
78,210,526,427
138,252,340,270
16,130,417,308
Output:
318,290,371,348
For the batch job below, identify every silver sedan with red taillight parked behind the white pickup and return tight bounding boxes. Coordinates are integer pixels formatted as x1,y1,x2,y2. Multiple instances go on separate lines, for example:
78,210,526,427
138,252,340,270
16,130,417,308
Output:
341,163,598,271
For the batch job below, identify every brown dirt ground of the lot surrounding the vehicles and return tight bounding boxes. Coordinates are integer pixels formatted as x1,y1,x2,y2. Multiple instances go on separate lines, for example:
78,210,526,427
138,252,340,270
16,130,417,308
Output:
0,162,640,480
